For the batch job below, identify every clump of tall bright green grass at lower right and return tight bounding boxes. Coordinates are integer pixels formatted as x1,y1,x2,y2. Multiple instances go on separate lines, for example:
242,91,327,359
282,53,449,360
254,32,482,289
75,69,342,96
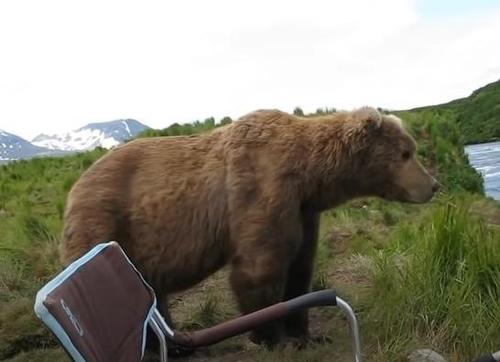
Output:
367,202,500,360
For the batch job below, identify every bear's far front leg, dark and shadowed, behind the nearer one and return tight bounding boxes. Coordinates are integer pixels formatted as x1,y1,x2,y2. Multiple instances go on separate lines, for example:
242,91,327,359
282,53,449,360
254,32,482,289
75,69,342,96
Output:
285,211,319,339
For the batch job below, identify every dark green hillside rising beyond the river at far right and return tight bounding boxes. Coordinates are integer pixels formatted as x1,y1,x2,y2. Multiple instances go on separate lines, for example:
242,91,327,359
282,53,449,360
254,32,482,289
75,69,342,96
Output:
413,80,500,144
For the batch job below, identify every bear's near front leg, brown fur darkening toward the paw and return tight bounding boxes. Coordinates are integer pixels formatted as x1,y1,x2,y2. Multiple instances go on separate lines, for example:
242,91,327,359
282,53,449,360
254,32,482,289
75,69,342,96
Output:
230,188,302,347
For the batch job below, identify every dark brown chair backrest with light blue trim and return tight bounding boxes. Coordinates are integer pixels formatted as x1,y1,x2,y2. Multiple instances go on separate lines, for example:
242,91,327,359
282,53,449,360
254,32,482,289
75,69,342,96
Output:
35,241,156,361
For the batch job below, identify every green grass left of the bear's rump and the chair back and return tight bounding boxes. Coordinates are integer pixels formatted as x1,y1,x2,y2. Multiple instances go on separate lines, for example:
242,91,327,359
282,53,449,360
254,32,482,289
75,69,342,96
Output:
0,150,104,360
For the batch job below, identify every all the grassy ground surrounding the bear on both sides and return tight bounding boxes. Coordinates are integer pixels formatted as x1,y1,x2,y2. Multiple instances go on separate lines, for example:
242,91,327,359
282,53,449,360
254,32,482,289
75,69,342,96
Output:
0,103,500,361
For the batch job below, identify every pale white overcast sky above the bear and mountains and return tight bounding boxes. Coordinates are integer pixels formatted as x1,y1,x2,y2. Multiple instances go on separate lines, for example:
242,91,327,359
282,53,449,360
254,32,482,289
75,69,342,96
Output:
0,0,500,139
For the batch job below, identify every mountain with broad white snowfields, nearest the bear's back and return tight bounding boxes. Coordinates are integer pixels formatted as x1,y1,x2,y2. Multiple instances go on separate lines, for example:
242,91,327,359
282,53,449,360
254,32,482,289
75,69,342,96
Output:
31,119,149,151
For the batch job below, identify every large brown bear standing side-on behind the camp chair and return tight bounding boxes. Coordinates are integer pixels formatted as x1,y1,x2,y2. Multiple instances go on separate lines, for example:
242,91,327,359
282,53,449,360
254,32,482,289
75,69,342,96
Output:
61,107,438,345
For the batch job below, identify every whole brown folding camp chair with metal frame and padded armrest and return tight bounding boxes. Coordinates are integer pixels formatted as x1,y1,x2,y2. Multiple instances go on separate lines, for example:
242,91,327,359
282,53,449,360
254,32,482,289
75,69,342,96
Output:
35,241,362,362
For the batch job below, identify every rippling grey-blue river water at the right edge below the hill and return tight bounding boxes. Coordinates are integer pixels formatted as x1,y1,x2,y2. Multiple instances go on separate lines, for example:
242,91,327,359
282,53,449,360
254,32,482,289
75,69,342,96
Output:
465,142,500,200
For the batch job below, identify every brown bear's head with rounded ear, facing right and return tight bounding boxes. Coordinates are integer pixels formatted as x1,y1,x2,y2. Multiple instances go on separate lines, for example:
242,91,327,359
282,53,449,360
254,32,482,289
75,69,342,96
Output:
343,107,439,203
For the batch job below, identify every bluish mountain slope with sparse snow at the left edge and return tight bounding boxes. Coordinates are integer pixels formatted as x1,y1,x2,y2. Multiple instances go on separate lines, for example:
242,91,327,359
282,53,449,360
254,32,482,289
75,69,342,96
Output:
0,130,66,164
